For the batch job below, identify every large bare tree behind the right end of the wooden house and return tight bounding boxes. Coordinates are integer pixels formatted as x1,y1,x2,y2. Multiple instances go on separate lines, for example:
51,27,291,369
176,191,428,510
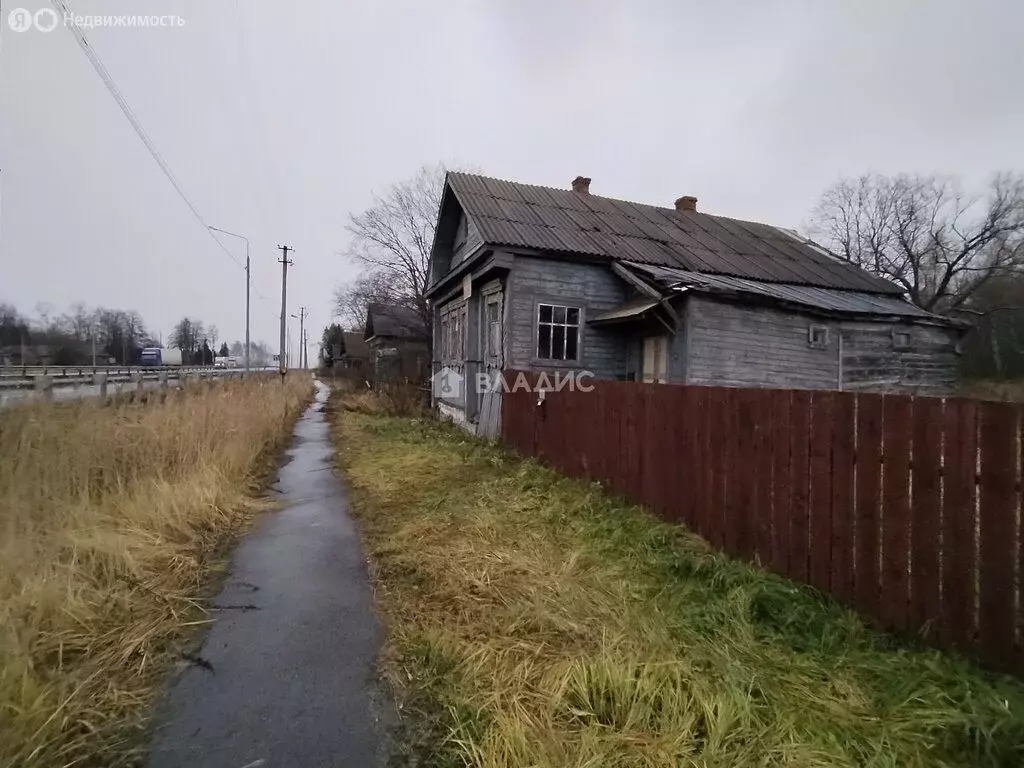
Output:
811,173,1024,312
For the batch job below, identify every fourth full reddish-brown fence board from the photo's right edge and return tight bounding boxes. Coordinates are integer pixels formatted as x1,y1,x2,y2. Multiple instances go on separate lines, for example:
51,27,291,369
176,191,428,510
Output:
882,395,911,630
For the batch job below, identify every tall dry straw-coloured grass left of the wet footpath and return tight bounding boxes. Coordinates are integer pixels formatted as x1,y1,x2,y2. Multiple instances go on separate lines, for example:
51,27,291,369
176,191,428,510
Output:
0,377,311,768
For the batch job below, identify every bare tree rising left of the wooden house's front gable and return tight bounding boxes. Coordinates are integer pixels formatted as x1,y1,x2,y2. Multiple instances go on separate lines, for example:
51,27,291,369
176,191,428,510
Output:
346,165,446,326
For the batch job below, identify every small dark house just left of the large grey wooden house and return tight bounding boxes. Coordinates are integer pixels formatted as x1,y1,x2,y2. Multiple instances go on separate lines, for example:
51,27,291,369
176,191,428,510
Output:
366,304,430,383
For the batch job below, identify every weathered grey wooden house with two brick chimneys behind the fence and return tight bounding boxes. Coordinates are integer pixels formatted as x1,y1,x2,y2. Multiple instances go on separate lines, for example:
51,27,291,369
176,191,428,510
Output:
427,173,964,434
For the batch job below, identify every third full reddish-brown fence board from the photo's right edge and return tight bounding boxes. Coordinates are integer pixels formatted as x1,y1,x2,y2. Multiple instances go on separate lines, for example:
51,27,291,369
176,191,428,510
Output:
909,397,942,637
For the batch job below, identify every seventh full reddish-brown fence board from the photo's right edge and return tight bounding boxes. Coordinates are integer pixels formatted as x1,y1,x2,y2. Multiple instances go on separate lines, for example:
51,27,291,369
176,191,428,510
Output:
809,392,836,592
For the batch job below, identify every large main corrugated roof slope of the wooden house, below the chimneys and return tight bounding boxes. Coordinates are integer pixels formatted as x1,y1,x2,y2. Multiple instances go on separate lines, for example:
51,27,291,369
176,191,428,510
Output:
447,172,902,295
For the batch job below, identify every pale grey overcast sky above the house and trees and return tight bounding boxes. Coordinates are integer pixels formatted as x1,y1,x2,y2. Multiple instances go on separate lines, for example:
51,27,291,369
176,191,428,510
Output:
0,0,1024,354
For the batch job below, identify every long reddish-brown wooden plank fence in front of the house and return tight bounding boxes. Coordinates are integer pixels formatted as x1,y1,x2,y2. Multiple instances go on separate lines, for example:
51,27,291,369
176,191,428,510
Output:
502,376,1024,675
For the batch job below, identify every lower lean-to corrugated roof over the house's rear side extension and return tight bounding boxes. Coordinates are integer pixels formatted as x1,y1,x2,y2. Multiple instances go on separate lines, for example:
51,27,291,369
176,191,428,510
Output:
628,263,955,325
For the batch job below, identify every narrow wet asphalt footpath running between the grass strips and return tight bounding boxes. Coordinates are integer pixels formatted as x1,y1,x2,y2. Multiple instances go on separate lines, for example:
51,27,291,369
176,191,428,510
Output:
143,382,386,768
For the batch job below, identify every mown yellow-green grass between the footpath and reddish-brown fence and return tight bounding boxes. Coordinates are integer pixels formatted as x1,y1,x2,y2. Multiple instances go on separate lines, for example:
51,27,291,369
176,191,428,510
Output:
333,409,1024,768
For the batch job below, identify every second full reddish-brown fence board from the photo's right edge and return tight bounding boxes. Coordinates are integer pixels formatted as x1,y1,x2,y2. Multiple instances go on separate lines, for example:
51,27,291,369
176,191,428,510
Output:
939,399,978,651
